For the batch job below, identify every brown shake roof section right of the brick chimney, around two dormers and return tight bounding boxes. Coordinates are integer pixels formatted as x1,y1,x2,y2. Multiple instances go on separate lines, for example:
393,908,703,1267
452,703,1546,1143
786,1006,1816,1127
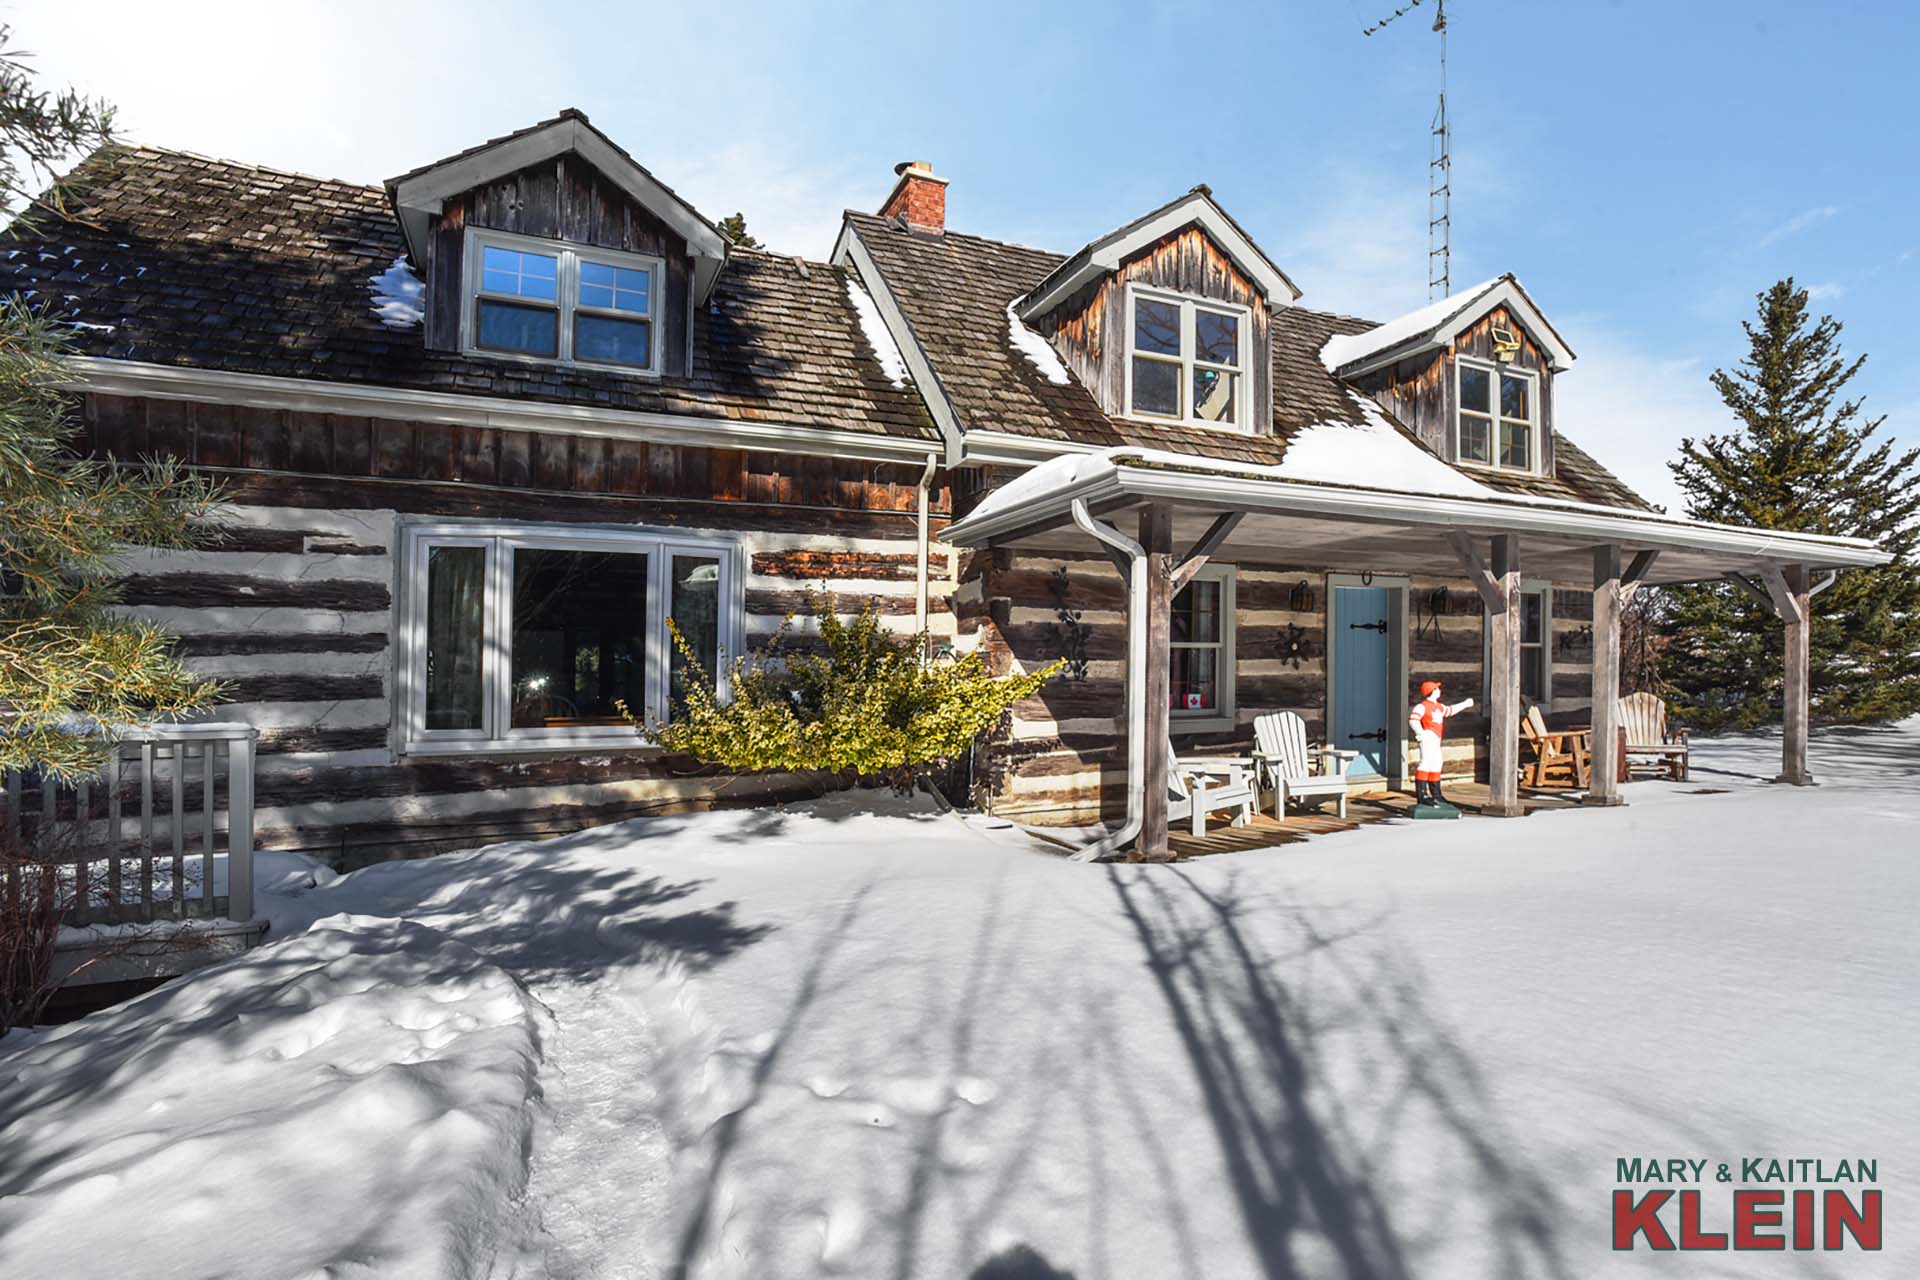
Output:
845,211,1647,509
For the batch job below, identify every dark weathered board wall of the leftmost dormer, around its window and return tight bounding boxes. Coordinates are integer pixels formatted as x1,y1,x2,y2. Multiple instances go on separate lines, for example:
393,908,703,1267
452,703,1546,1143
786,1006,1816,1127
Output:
424,155,693,374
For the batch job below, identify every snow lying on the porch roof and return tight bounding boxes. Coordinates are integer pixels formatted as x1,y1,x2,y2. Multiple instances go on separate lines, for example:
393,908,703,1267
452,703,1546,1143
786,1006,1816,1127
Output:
970,395,1489,520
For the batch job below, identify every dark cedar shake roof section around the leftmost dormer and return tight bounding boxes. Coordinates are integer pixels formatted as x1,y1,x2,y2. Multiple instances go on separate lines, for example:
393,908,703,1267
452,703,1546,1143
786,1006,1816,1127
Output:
0,148,939,441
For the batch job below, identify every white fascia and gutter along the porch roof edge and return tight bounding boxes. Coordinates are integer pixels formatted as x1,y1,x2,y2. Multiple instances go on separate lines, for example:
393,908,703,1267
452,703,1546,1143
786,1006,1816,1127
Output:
941,454,1893,568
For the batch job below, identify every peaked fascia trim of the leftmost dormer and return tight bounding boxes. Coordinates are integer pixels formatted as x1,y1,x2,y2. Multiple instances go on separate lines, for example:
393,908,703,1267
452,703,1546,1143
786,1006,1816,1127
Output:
394,119,726,301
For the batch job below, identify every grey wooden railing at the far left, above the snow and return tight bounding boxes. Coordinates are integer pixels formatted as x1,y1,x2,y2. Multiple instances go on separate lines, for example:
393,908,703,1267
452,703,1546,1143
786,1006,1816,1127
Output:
0,723,257,925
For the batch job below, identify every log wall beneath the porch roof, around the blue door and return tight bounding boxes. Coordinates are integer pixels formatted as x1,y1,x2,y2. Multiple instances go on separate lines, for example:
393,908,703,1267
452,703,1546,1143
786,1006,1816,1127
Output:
954,551,1592,825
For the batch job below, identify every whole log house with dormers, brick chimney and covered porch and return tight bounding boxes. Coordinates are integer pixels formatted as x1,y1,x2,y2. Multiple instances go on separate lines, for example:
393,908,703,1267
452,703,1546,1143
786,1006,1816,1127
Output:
0,111,1884,862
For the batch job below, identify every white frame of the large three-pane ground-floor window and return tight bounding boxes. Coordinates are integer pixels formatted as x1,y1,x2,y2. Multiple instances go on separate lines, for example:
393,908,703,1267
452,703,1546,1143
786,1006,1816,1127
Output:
394,520,747,756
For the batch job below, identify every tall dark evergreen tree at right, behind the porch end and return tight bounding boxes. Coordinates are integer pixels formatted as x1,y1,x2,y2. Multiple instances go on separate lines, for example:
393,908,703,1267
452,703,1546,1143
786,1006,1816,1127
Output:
1661,278,1920,729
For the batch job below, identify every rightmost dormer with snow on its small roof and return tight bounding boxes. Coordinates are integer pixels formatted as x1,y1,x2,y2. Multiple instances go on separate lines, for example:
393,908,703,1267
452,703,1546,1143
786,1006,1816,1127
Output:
1321,274,1574,476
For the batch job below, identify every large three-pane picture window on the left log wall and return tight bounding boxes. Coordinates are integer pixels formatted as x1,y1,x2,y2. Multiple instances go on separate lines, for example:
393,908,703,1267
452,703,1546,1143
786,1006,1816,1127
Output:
399,522,743,750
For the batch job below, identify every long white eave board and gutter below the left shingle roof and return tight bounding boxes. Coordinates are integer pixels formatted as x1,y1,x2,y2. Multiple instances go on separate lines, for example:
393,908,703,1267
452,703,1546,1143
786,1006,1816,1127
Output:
65,355,943,462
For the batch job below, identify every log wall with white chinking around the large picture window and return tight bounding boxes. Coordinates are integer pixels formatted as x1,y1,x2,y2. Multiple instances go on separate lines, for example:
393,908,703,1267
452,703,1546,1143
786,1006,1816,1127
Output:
84,395,954,865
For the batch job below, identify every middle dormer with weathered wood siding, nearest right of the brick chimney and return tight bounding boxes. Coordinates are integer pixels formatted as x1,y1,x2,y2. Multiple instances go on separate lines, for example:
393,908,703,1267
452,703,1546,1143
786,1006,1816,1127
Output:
1014,186,1300,436
